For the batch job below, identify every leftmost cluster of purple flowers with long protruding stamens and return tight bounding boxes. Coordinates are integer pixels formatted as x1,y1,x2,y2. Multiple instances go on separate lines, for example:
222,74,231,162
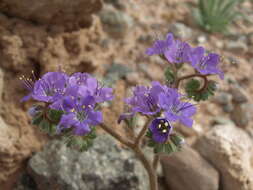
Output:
22,72,113,135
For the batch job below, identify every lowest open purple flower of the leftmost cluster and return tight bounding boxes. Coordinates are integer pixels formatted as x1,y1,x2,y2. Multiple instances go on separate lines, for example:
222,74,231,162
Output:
57,96,103,135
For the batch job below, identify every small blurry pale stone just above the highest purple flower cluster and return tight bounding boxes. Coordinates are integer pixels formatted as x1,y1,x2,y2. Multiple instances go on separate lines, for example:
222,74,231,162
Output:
169,22,193,39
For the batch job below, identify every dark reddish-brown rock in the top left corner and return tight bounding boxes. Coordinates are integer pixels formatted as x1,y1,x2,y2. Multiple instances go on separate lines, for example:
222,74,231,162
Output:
0,0,102,28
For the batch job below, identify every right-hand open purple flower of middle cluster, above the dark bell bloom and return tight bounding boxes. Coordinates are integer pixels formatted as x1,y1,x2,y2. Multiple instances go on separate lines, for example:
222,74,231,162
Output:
159,91,196,127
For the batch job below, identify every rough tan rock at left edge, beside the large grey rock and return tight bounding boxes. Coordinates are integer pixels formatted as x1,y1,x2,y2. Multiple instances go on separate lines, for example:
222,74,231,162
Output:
0,117,43,184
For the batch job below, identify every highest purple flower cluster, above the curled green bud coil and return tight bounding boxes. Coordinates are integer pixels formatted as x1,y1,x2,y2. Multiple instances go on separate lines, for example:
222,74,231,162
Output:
146,33,224,79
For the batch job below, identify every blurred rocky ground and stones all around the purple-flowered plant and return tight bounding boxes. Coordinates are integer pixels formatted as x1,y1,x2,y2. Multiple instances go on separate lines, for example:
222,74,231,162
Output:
0,0,253,190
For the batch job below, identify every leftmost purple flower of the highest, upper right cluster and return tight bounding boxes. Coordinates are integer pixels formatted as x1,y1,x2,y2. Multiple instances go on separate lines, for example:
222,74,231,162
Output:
146,33,174,55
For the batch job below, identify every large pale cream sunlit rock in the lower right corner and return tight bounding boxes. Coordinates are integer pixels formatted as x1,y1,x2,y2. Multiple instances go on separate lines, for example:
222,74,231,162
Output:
194,125,253,190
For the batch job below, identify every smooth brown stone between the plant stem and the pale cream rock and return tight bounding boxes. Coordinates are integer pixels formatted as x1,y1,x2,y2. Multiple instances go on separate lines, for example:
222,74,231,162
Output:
161,146,219,190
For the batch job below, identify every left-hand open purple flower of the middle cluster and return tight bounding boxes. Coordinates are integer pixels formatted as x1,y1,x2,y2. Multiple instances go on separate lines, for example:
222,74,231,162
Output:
125,82,164,115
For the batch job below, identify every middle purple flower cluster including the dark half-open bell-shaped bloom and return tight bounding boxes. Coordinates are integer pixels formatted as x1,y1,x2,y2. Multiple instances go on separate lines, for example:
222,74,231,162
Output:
120,82,196,142
